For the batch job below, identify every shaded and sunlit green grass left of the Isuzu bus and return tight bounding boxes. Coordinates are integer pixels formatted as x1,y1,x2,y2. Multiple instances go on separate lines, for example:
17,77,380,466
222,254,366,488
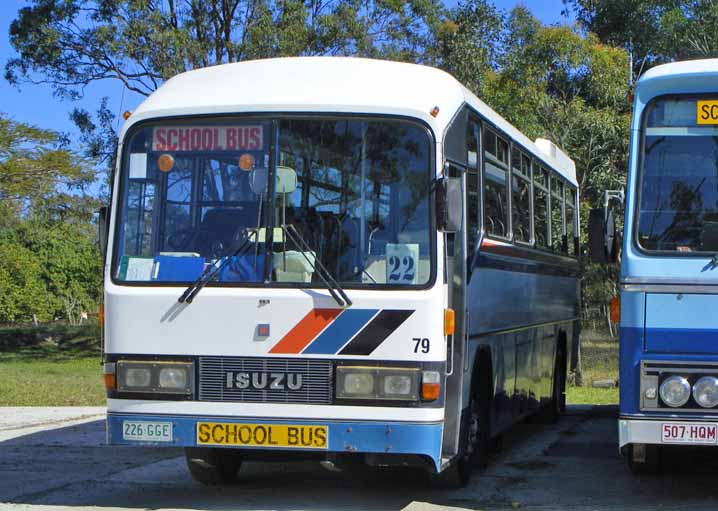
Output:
0,325,105,406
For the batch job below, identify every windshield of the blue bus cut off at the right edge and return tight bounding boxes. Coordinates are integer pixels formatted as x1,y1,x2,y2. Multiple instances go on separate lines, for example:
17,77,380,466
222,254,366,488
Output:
637,98,718,254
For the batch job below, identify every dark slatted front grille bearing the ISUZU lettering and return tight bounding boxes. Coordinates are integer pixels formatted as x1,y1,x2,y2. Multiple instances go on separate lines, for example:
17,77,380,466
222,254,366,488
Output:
199,357,334,404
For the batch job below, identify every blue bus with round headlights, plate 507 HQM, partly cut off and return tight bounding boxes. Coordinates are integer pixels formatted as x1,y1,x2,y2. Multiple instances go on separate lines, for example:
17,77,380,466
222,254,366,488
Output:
596,60,718,471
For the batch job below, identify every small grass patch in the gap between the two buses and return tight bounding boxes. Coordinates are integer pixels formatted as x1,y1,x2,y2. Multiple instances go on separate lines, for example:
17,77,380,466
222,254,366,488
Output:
566,332,618,405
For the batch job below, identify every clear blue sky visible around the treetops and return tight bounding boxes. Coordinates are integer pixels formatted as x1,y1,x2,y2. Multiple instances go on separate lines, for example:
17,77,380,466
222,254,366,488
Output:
0,0,568,141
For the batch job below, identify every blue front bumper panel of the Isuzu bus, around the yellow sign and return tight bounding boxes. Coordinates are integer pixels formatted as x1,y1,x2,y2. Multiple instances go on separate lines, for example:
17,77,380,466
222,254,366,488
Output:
107,413,443,469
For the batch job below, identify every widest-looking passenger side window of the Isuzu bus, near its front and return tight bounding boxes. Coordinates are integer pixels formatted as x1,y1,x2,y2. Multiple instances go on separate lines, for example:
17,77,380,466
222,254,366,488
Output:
484,128,509,237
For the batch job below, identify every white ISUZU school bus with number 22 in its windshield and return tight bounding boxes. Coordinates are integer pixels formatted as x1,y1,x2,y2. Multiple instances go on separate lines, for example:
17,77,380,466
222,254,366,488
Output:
104,58,579,484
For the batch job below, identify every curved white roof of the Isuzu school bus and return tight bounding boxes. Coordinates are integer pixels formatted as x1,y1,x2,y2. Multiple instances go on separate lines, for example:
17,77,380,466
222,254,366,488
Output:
121,57,576,185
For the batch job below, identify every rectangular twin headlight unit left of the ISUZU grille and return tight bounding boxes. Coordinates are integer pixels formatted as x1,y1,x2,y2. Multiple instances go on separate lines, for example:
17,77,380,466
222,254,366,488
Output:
116,360,194,395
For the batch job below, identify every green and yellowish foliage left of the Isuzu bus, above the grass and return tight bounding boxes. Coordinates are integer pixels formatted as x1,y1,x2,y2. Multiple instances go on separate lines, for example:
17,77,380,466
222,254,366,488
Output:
0,116,101,323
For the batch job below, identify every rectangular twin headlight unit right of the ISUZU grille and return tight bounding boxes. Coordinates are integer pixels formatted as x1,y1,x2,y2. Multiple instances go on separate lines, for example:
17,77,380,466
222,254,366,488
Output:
336,366,419,401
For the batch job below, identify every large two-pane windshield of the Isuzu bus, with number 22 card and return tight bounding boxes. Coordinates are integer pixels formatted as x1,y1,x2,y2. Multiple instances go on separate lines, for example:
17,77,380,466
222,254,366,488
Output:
112,117,433,287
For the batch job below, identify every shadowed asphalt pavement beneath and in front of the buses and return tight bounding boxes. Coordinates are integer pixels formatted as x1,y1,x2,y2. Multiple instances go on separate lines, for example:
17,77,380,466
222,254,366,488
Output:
0,407,718,511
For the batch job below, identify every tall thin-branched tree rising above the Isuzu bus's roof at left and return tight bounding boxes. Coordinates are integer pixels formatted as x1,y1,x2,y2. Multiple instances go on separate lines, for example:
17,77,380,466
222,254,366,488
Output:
5,0,440,98
